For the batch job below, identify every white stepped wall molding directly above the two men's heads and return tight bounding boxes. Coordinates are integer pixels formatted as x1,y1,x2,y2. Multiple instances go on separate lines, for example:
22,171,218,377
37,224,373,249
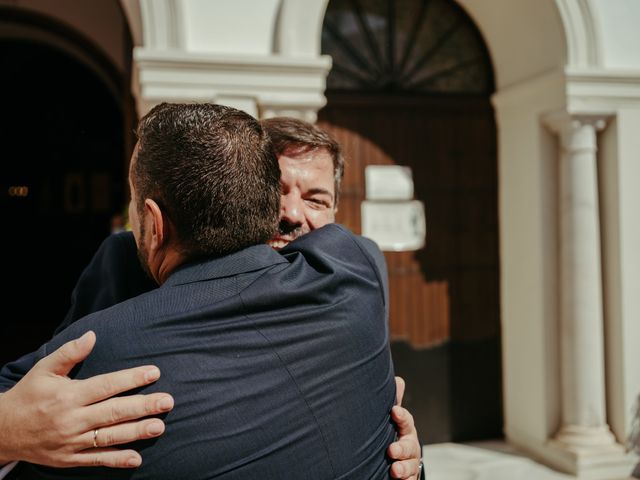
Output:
134,47,331,121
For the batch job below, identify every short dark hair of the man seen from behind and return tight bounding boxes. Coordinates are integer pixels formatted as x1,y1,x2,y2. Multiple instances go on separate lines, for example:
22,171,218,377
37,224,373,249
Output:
132,103,280,259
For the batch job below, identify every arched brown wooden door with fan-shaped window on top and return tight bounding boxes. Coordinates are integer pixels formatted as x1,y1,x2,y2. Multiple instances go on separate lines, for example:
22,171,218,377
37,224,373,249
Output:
319,0,502,443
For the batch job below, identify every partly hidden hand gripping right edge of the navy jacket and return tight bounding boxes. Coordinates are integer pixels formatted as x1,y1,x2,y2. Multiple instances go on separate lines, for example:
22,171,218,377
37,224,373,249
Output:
387,377,422,480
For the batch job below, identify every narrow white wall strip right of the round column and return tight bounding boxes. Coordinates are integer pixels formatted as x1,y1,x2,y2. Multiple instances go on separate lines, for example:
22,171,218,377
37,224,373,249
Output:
599,106,640,442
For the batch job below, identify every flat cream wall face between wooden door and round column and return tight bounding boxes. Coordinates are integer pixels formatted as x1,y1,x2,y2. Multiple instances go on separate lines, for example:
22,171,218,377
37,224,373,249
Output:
494,74,564,451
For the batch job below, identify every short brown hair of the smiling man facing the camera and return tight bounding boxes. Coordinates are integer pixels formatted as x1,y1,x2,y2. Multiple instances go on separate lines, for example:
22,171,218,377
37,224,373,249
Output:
261,117,344,207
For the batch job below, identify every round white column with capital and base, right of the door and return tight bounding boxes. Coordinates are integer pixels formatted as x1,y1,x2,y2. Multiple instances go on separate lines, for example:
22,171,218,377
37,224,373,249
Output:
547,115,622,462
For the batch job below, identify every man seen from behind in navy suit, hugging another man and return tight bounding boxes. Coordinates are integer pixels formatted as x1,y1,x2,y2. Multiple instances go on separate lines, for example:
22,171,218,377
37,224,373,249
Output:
3,104,395,479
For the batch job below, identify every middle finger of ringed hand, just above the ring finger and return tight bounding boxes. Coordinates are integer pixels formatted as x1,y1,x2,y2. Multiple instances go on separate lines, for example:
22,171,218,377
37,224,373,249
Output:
82,393,174,429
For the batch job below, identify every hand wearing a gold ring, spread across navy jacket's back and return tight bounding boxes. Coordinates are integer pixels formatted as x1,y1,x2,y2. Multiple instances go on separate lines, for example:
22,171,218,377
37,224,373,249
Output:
0,332,173,468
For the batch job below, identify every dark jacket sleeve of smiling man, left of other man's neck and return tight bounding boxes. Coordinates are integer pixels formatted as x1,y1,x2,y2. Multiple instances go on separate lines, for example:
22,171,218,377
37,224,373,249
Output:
0,232,156,392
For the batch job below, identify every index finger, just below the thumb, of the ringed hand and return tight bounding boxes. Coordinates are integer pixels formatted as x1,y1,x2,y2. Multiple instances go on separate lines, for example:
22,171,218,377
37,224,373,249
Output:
75,365,160,405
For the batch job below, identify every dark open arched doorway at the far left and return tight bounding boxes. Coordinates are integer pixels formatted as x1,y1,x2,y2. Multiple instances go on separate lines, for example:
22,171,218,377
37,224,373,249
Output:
0,40,126,364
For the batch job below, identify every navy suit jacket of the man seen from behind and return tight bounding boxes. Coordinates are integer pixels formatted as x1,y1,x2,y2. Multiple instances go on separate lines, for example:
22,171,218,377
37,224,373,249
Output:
6,225,395,480
